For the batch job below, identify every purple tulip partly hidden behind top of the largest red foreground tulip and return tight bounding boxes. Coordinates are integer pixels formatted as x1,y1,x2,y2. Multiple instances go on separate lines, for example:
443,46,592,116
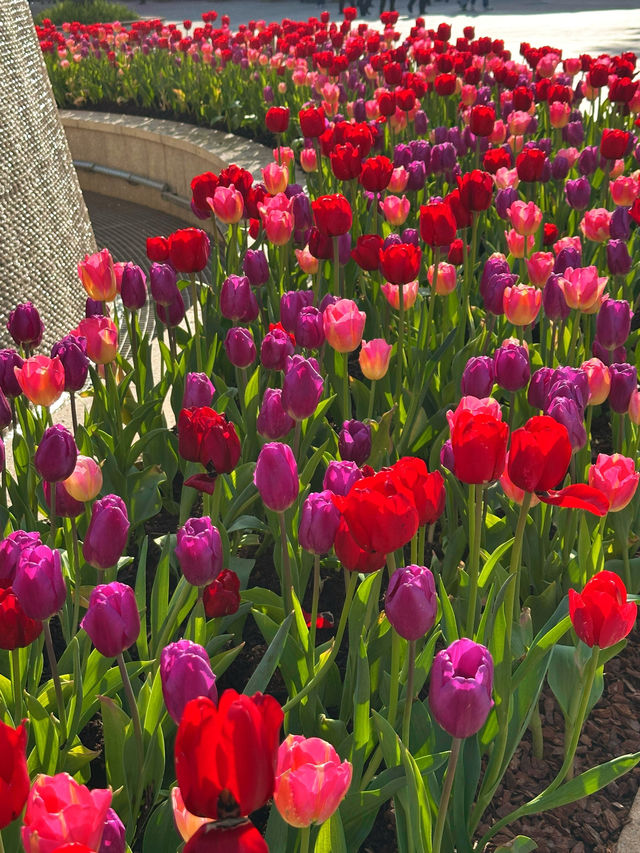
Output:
160,640,218,724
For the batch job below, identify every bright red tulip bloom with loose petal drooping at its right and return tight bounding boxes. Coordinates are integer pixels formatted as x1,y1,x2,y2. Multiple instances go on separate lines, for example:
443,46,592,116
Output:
509,415,571,492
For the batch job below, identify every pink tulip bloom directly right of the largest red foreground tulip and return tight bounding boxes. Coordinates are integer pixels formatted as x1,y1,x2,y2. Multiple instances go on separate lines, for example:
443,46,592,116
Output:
273,735,353,827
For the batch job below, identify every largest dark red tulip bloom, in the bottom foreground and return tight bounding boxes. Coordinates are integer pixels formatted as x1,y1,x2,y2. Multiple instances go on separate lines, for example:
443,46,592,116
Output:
175,690,283,819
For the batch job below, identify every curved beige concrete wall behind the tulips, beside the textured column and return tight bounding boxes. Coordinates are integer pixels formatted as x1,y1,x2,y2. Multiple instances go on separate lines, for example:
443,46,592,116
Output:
60,110,273,225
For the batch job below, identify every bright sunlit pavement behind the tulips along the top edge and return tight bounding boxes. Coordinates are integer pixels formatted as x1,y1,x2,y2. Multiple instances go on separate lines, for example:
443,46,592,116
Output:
128,0,640,56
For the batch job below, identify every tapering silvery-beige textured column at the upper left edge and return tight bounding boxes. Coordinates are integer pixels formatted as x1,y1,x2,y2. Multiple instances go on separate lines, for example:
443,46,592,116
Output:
0,0,95,348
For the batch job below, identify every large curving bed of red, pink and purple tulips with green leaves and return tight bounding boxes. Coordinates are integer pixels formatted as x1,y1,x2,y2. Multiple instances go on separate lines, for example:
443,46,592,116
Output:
0,10,640,853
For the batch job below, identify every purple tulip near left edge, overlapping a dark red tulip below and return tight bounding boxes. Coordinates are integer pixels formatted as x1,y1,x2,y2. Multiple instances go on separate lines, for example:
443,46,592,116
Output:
12,545,67,621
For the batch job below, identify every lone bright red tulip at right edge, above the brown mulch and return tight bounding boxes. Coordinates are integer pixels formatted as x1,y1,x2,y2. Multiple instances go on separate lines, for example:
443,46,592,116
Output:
569,571,638,649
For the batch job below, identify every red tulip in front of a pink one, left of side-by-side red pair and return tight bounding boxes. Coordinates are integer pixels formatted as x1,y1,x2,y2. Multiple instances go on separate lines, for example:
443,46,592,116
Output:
451,410,509,484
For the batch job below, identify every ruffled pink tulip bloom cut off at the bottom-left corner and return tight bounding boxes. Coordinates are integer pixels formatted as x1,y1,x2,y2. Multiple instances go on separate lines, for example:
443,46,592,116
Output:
22,773,111,853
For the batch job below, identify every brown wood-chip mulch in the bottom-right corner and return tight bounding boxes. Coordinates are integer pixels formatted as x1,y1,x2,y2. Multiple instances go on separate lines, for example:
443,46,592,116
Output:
480,628,640,853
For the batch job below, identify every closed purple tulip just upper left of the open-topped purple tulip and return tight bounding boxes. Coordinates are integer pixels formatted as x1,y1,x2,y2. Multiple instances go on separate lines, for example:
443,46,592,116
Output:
384,565,438,640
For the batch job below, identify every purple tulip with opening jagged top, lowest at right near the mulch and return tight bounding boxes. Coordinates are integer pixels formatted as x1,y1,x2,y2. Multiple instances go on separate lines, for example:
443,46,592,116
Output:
429,637,493,738
